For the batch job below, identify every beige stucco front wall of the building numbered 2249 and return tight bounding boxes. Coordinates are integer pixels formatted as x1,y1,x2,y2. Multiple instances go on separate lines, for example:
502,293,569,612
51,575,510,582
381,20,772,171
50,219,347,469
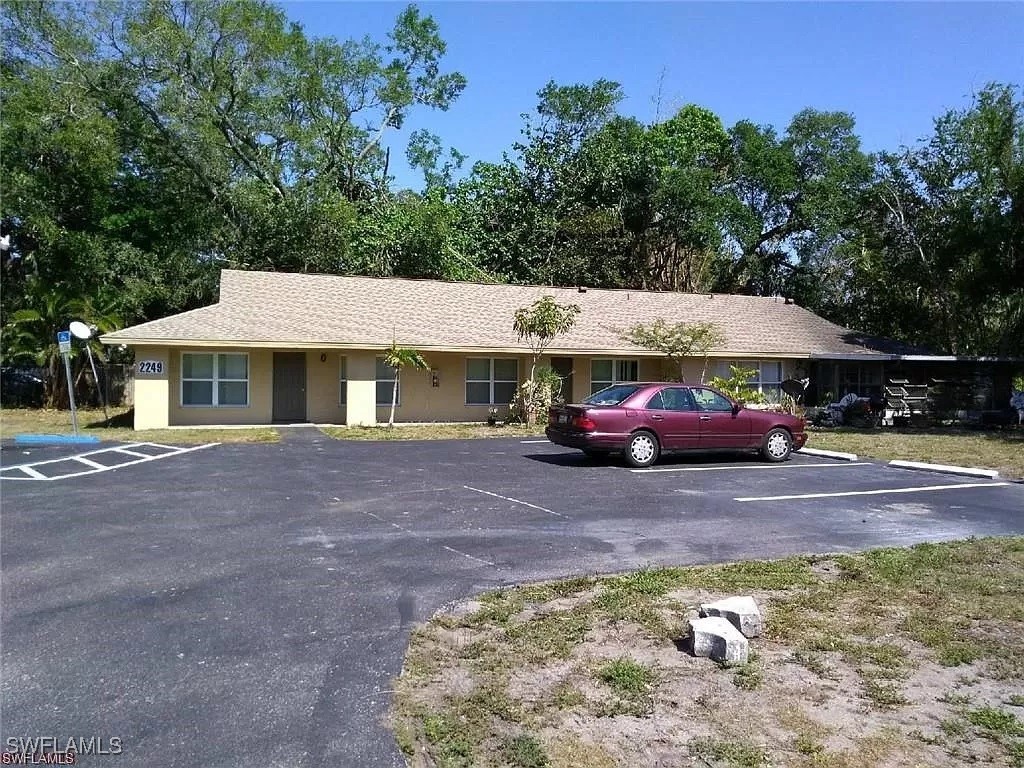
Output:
125,347,802,429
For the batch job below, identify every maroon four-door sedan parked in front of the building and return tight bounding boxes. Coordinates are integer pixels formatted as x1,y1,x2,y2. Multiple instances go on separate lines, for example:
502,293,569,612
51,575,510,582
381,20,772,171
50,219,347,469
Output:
546,382,807,467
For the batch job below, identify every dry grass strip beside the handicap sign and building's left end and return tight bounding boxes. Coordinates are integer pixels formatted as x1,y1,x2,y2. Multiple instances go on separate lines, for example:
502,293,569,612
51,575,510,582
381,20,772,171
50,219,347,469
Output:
0,408,281,444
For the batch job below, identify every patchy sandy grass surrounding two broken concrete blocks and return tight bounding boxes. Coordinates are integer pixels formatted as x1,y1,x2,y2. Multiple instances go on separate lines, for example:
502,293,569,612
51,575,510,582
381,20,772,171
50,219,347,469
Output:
391,538,1024,768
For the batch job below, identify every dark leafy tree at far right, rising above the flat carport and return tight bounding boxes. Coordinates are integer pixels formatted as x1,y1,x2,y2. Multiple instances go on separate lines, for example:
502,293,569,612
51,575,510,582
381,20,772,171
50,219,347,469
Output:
849,84,1024,355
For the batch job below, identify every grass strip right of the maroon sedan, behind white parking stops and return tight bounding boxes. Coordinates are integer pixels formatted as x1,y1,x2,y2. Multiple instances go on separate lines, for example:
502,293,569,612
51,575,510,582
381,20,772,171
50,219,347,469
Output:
807,427,1024,477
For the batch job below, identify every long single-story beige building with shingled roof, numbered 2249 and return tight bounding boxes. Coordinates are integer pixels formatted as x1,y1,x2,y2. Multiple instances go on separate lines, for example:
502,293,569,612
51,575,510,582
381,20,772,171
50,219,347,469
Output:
101,269,1011,429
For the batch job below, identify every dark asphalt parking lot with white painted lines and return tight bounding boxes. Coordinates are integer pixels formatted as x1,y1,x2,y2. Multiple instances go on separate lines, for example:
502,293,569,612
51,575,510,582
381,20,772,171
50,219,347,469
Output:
0,430,1024,768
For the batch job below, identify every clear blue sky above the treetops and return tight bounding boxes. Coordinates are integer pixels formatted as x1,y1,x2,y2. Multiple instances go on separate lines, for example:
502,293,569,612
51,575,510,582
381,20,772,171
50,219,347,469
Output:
284,2,1024,188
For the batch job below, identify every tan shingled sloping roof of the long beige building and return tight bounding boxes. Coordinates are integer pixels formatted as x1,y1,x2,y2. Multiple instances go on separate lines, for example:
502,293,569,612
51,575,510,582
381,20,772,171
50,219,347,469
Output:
101,269,920,358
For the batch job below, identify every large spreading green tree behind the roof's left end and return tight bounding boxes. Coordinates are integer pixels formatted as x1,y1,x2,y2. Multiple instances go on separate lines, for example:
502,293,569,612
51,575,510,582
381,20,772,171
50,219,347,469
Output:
0,0,465,322
